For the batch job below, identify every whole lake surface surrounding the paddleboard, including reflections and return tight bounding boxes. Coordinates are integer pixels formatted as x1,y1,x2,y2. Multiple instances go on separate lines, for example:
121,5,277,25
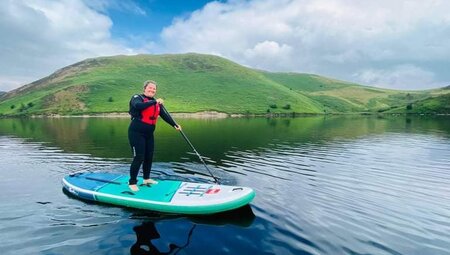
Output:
0,117,450,255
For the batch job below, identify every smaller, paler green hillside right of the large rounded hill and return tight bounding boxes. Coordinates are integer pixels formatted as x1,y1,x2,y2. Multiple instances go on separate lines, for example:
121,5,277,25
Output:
263,72,450,113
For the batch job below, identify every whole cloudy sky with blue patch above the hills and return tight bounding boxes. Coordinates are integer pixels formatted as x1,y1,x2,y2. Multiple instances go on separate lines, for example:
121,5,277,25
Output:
0,0,450,91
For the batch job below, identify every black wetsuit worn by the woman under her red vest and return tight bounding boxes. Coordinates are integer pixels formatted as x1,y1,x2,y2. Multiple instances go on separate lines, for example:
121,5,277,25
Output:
128,95,177,185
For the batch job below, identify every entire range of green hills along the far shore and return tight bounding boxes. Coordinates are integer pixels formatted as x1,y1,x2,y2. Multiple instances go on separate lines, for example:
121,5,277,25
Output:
0,53,450,115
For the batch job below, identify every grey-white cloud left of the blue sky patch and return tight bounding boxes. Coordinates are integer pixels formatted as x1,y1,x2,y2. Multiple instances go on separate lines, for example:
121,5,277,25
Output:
0,0,134,90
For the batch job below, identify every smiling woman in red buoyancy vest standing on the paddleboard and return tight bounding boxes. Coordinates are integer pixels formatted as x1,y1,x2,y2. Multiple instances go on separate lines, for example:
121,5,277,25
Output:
128,81,181,191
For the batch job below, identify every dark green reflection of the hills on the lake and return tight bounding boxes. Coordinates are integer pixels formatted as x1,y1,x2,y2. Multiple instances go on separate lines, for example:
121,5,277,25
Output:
0,116,450,162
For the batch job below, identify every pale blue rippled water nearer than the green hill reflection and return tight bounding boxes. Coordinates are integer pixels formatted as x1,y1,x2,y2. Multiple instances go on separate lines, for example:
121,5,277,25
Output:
0,129,450,254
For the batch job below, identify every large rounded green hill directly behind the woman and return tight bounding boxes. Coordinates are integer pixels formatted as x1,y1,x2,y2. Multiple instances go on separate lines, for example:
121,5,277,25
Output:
0,54,322,114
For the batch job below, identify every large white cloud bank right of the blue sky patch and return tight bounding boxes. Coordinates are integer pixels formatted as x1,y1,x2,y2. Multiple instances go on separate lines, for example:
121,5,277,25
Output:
160,0,450,88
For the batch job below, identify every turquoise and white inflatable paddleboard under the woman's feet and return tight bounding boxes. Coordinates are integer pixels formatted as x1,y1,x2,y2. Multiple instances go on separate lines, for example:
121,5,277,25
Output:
62,173,255,214
